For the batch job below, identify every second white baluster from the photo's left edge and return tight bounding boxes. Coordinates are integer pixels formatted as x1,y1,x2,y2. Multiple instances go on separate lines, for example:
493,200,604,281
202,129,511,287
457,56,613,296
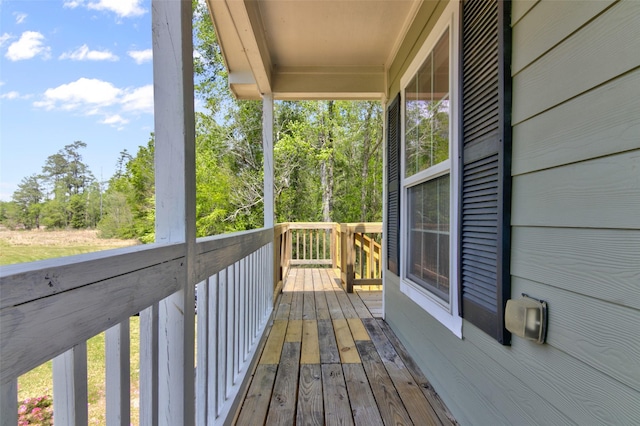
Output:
53,342,89,425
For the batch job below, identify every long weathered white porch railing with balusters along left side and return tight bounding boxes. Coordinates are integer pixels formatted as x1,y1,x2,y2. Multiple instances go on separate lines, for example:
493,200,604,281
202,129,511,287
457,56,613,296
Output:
0,229,273,426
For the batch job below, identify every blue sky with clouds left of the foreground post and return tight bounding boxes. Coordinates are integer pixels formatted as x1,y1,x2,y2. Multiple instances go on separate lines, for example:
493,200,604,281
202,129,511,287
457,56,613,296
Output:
0,0,153,201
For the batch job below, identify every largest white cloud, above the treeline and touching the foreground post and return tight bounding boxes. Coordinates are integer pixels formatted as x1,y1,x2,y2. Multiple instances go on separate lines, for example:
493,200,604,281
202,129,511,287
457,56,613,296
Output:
33,78,153,128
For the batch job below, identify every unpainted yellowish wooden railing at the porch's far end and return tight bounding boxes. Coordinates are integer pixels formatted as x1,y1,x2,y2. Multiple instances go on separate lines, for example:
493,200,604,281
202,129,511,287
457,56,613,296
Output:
274,222,382,292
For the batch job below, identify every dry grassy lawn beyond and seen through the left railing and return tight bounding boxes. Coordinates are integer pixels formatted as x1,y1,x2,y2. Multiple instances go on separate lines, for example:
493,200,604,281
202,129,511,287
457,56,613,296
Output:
0,230,140,425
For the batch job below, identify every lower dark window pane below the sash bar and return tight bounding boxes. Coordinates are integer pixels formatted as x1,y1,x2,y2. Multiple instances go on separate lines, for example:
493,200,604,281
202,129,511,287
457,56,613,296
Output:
407,175,449,303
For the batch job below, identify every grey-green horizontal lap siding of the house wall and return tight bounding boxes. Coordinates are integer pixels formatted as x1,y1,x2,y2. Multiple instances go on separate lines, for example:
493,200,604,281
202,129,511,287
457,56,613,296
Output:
385,0,640,425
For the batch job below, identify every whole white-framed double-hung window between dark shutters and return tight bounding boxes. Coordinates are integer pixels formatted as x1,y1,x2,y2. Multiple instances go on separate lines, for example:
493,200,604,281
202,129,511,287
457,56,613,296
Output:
400,2,462,337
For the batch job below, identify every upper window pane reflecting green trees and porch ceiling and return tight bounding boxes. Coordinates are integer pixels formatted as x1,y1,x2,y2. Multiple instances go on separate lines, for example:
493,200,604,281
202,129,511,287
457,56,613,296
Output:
405,30,449,177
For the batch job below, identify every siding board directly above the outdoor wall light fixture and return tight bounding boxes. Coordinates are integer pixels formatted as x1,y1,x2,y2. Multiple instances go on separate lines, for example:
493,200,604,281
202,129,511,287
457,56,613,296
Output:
511,227,640,309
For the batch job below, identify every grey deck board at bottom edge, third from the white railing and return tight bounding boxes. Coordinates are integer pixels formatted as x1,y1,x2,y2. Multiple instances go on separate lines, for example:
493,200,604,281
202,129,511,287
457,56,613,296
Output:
296,364,324,426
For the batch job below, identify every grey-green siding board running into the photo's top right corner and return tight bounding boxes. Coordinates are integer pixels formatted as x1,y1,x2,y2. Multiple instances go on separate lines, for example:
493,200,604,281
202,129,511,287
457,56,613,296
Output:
512,1,640,125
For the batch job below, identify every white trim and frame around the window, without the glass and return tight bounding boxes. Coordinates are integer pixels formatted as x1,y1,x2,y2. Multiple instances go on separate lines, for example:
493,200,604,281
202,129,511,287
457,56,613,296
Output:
399,1,462,338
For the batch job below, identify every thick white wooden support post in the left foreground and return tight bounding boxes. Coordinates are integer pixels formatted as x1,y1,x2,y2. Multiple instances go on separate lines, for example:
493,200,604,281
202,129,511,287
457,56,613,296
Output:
152,0,196,426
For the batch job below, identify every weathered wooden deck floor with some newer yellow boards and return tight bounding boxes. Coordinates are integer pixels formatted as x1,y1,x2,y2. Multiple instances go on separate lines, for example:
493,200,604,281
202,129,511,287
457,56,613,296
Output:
236,269,455,426
